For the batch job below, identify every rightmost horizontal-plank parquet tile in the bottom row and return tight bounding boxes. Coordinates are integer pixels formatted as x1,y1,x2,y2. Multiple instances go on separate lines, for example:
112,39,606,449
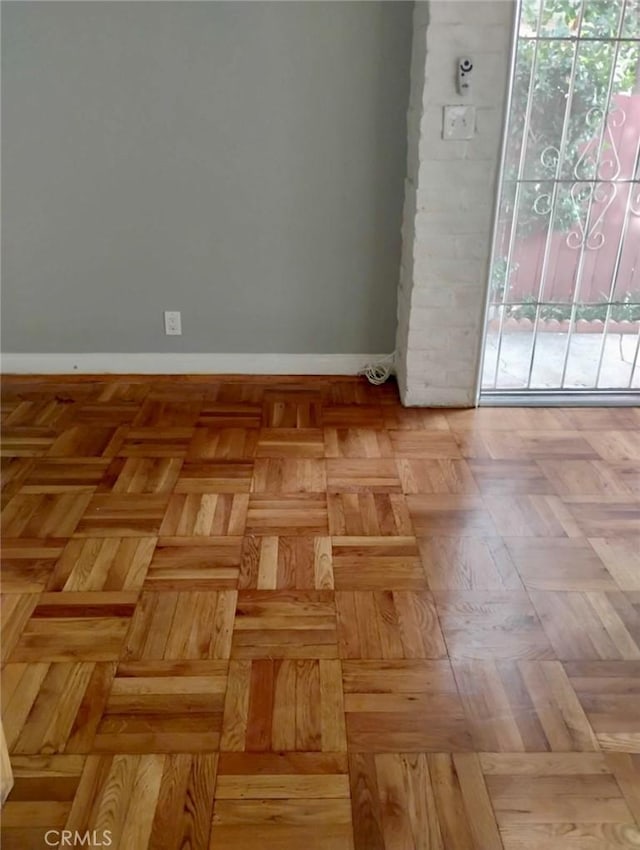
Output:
480,753,640,850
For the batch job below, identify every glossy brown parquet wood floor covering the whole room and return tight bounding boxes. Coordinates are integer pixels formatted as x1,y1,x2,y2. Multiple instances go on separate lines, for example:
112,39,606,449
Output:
1,376,640,850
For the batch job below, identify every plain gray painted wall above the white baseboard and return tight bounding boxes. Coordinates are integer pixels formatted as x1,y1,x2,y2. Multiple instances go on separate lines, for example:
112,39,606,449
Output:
2,2,412,353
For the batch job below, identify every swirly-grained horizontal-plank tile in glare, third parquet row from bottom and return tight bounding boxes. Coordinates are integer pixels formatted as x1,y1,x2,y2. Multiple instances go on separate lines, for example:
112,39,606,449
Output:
434,590,555,660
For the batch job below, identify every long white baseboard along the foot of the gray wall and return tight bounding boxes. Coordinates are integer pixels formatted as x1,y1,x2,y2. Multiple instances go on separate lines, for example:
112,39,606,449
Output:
0,352,386,375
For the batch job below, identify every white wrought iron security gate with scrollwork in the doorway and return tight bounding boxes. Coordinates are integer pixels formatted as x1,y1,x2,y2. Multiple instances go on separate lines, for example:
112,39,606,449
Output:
481,0,640,401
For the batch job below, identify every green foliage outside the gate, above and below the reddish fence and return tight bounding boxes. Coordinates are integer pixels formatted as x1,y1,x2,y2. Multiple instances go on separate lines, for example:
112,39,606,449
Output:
491,0,640,304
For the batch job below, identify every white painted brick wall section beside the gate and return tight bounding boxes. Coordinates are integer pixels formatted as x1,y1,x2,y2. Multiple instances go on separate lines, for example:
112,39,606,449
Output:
396,0,515,407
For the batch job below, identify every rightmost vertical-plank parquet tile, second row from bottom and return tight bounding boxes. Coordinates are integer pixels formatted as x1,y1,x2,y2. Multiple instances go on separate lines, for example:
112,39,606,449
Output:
452,659,599,753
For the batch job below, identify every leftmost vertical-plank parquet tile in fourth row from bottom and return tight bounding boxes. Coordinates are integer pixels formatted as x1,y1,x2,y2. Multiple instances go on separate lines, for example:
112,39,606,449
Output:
46,537,156,591
